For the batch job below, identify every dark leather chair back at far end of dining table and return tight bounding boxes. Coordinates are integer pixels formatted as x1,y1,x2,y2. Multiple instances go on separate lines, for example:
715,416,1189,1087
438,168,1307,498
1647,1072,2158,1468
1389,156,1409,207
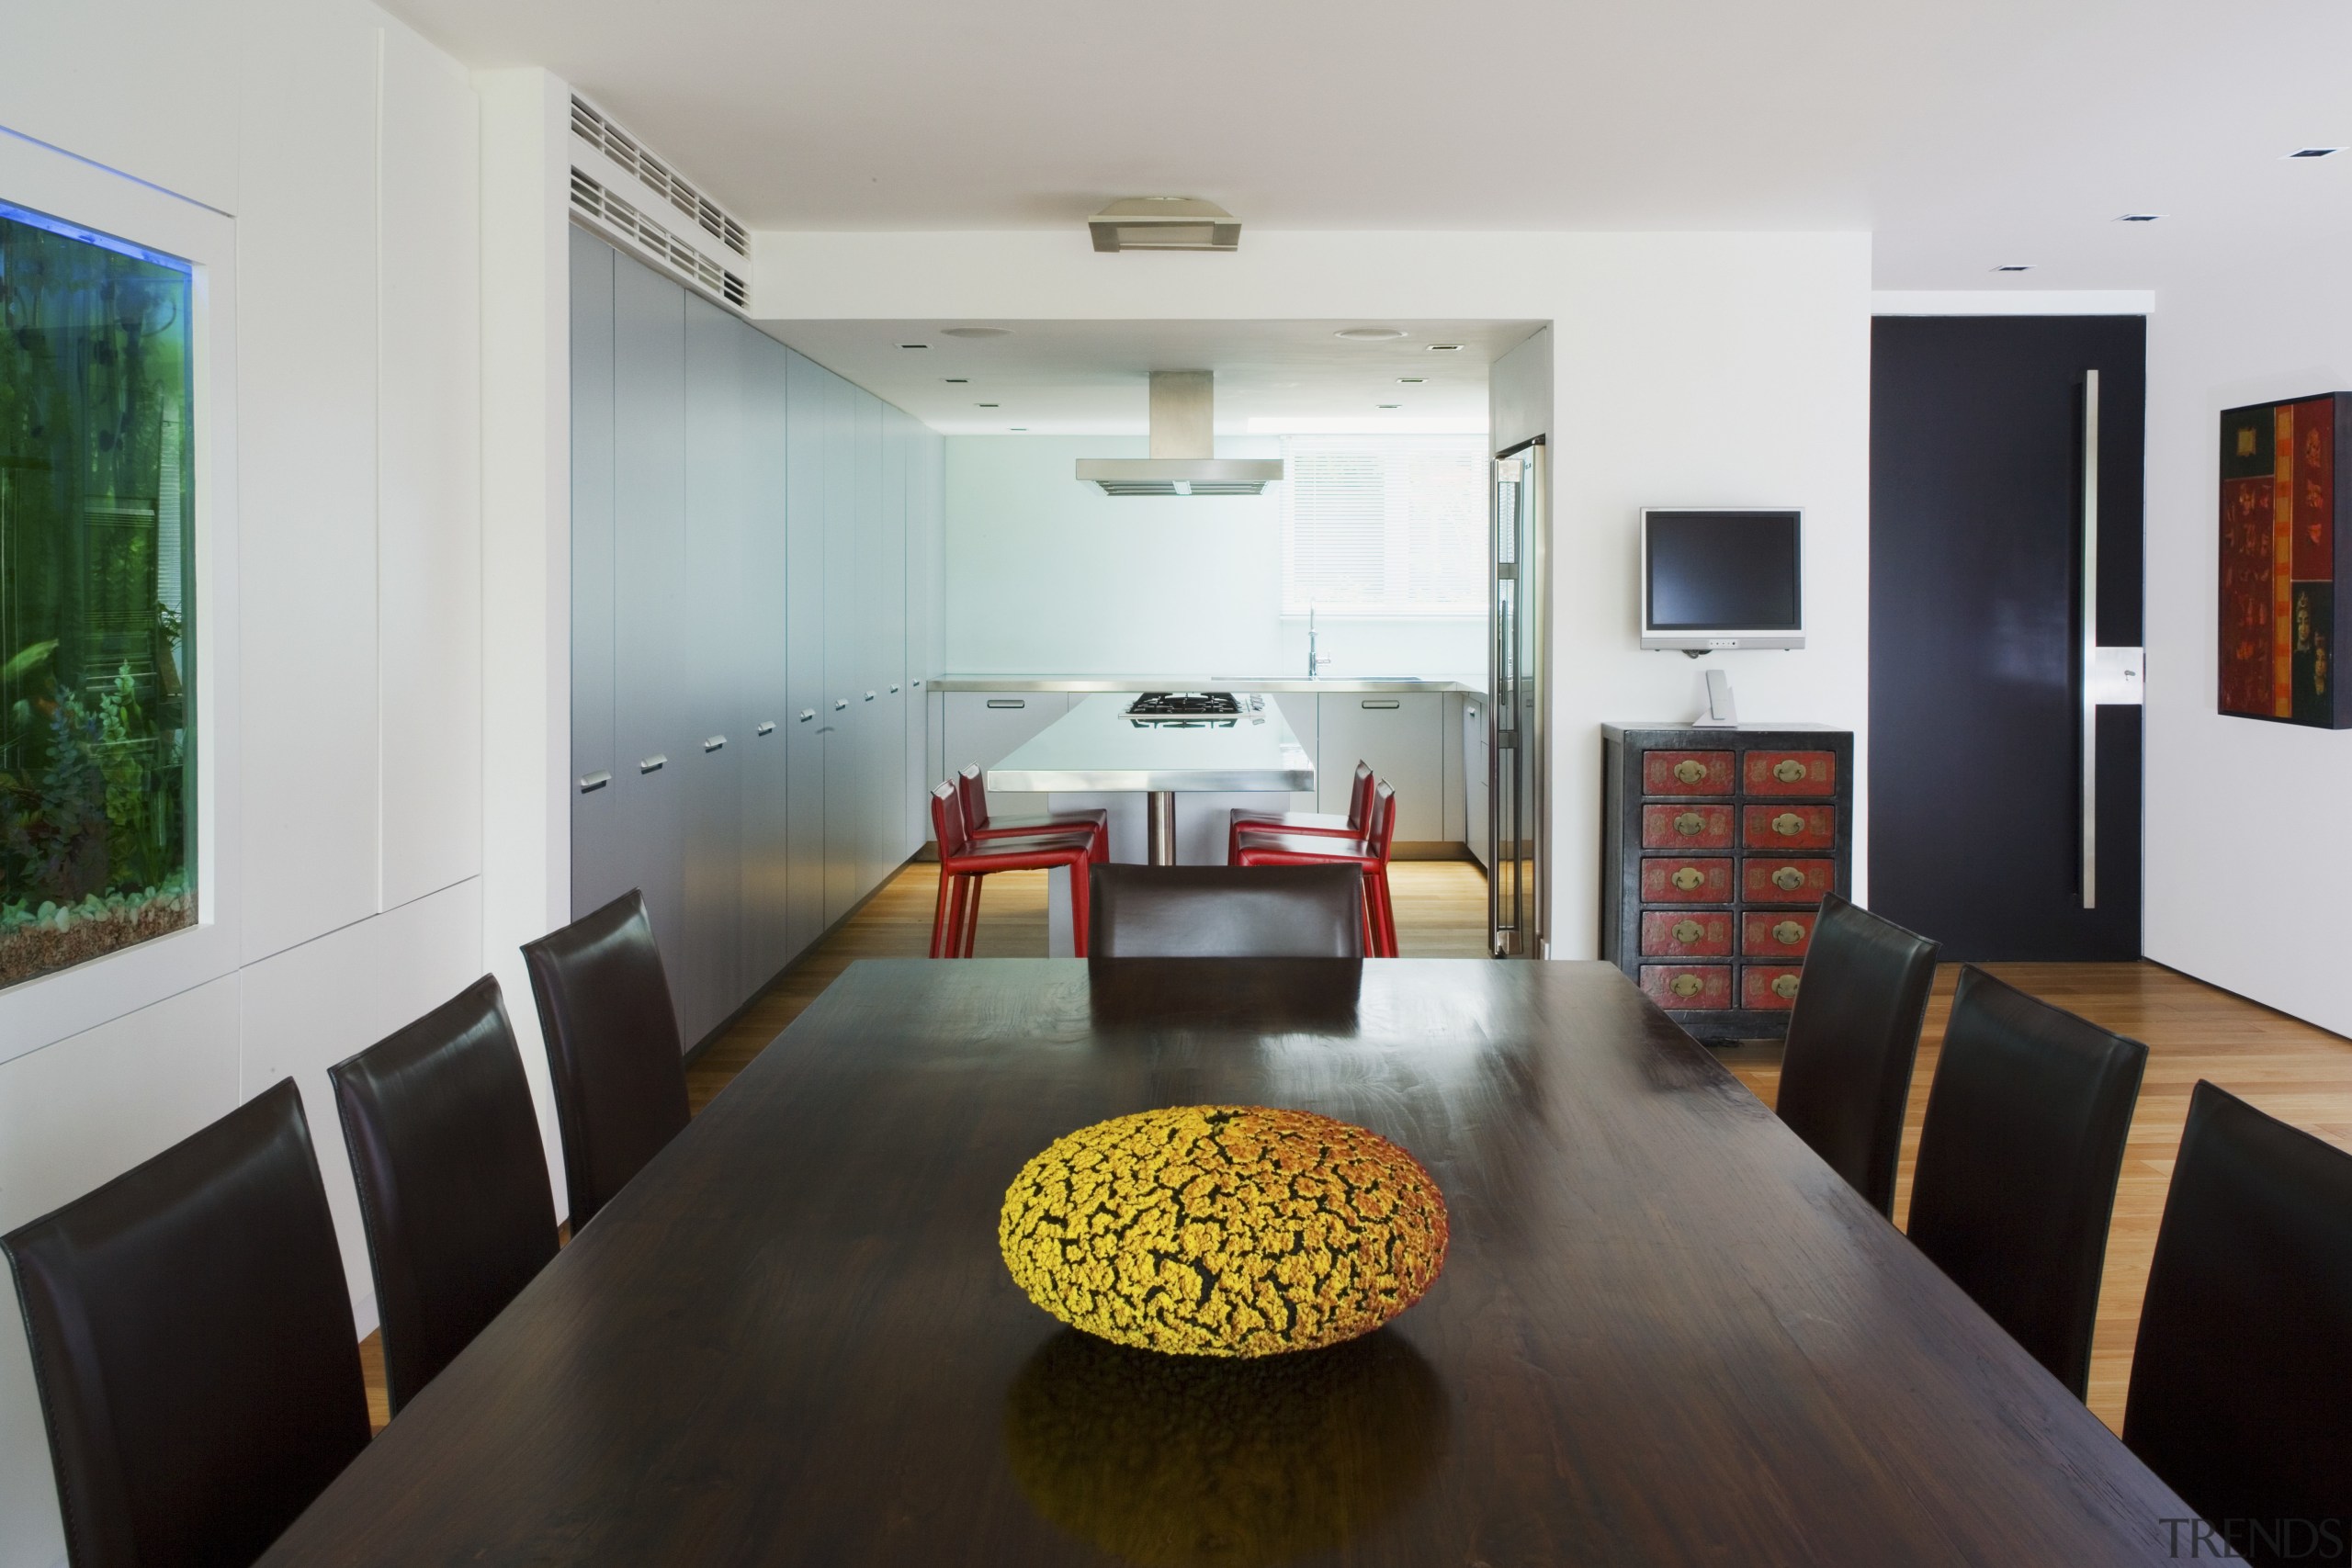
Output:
1087,863,1364,959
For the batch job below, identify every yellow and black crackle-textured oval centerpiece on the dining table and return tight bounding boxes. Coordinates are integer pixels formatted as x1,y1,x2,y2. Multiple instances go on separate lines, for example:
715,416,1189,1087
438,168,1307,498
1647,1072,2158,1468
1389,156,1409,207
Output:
997,1105,1446,1357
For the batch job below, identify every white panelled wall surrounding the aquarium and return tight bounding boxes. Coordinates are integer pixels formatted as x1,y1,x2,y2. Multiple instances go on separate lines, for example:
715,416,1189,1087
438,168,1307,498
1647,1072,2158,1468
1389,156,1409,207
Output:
0,0,486,1568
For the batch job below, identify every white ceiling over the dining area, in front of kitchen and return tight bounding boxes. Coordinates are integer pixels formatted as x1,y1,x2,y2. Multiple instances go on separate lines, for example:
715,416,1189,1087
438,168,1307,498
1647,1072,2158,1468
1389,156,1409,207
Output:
388,0,2352,289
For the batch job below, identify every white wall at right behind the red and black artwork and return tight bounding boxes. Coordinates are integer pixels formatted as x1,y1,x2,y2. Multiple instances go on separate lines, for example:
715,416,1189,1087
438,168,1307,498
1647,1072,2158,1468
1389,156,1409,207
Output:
2143,254,2352,1034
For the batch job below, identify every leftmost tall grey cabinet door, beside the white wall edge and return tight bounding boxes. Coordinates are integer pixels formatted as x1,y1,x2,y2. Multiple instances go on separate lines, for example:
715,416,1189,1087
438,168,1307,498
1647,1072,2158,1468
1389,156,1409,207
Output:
571,228,630,917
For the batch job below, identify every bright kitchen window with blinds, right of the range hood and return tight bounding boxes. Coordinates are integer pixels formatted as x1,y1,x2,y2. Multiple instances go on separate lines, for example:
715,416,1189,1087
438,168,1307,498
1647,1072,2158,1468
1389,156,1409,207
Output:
1282,434,1487,616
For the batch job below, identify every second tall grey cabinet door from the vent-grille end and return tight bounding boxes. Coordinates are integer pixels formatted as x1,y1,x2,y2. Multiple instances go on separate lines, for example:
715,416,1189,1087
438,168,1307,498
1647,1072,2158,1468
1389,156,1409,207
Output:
612,254,687,1032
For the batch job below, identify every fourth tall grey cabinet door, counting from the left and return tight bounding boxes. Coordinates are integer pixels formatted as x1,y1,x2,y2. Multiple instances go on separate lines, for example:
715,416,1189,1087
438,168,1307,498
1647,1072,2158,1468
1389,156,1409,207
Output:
736,322,795,992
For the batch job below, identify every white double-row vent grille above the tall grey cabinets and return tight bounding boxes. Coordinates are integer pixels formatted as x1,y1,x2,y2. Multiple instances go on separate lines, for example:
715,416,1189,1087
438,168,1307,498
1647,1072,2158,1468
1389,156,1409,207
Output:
571,96,751,310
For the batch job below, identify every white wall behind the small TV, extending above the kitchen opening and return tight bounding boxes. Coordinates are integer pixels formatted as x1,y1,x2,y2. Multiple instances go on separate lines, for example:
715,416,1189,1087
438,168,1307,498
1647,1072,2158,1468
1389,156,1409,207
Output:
755,231,1870,957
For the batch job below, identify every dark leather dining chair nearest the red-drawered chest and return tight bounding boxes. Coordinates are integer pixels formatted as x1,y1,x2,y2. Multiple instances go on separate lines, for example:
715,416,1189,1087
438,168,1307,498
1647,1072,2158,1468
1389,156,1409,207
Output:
1773,894,1936,1215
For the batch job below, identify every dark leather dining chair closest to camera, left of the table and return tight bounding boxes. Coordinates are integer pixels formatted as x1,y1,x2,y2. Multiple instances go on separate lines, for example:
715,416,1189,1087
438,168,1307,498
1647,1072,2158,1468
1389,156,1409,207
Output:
0,1079,367,1568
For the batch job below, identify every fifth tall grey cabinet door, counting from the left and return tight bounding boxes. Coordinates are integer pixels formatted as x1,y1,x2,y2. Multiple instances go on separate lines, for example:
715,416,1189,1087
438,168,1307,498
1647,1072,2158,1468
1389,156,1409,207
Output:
786,350,832,952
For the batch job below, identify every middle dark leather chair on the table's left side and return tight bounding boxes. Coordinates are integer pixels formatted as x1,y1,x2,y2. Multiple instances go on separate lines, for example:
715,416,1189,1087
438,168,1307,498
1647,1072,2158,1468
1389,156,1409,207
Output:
327,976,555,1416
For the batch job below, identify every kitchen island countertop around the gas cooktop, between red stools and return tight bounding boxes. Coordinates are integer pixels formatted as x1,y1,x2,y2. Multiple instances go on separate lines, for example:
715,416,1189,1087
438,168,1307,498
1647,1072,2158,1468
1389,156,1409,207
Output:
988,686,1315,795
